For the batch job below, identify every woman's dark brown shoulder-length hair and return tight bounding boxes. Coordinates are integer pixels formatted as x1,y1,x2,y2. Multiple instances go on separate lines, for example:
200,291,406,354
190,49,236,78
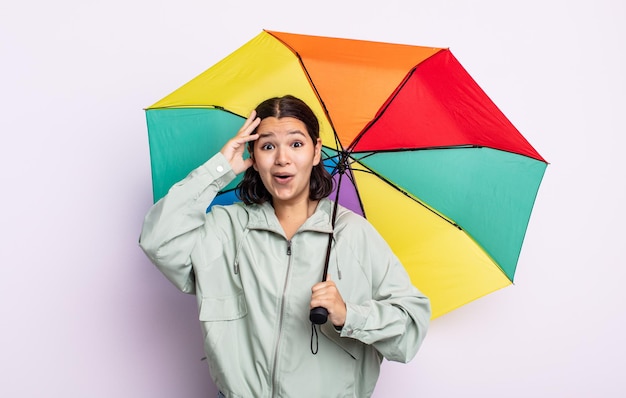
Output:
237,95,333,205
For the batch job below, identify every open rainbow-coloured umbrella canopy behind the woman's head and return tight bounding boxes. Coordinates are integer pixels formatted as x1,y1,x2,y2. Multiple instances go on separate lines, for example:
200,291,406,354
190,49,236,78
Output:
146,31,547,317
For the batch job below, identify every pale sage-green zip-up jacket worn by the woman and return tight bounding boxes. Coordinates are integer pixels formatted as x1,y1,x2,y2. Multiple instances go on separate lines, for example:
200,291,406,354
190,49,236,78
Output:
140,153,430,398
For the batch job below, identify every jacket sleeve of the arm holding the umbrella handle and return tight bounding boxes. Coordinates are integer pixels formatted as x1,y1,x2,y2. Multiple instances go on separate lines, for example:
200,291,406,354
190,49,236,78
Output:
341,218,431,363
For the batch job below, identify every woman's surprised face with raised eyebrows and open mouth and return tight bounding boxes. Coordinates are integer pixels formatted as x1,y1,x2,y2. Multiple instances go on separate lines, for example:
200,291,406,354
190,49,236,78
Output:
253,117,322,206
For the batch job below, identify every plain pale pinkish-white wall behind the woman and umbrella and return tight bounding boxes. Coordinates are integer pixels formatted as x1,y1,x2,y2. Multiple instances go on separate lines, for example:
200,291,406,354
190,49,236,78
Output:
0,0,626,398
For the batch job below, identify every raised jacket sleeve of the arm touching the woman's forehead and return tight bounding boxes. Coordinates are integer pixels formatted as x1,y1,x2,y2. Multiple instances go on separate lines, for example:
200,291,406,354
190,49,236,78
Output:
139,153,235,294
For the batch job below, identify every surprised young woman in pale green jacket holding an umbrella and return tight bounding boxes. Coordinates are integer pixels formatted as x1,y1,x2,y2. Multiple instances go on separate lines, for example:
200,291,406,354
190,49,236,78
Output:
140,96,430,398
